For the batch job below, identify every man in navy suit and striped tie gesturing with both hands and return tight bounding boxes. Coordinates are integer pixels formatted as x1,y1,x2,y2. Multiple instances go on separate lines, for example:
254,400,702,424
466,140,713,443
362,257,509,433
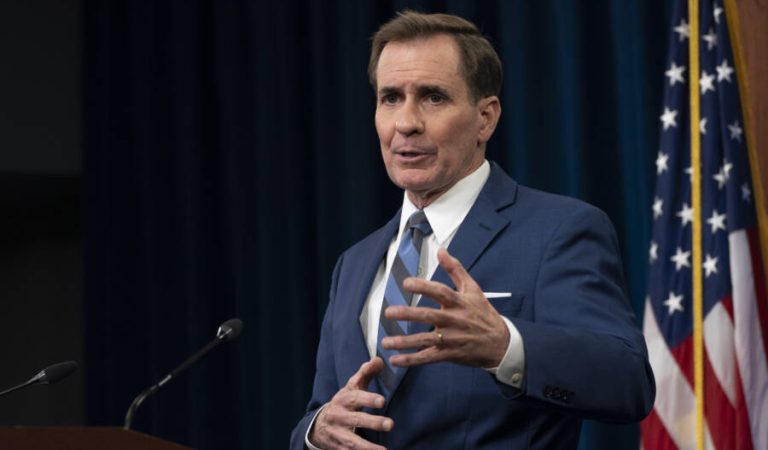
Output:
291,12,655,449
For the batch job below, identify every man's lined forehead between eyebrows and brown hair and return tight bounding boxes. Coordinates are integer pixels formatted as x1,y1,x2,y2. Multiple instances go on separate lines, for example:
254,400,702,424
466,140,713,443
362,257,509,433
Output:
376,35,466,89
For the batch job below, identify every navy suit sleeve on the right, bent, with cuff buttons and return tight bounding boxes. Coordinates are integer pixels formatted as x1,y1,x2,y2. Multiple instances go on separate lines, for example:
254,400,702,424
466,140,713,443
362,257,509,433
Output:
502,207,655,422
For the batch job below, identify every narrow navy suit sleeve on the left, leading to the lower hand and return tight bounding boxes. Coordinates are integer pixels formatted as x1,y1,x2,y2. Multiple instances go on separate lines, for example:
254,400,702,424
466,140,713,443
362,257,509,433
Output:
290,255,344,450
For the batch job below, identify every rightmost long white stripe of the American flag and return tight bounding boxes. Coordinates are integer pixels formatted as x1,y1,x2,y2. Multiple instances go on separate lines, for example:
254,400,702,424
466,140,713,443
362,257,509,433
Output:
728,230,768,449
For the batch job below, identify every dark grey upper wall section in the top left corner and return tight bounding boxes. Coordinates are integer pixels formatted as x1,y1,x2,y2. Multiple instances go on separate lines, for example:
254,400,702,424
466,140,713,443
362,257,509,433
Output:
0,0,82,174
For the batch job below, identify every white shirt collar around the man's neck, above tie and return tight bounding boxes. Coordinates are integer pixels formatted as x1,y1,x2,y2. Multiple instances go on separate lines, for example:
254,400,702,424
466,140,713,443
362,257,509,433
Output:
399,160,491,246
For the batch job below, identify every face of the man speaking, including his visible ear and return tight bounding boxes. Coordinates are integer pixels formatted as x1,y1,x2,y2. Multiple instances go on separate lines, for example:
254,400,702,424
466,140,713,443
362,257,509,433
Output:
376,35,500,208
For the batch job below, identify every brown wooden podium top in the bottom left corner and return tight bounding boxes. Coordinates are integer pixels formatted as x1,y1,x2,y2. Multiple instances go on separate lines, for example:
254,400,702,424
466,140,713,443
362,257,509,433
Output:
0,427,192,450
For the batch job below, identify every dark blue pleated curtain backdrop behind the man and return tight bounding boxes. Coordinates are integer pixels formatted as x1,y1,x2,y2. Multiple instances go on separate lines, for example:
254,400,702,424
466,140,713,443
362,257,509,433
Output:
83,0,670,450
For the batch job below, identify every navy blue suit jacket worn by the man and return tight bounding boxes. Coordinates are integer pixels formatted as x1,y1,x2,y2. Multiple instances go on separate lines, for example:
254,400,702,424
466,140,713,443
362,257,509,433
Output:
291,164,655,450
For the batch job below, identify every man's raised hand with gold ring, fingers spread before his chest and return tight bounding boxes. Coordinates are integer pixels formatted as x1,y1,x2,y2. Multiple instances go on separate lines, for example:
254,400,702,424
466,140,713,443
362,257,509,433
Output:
381,248,509,368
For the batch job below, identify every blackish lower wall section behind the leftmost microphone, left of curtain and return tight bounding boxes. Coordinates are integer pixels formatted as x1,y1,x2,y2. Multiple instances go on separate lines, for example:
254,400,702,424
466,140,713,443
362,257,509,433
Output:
0,174,84,425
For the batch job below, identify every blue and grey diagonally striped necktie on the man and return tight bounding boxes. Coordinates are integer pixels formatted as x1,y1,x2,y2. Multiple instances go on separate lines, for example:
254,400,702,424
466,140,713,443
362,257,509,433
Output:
376,210,432,397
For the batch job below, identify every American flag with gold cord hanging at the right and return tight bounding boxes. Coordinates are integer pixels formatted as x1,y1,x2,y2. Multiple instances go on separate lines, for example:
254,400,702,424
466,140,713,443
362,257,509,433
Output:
641,0,768,450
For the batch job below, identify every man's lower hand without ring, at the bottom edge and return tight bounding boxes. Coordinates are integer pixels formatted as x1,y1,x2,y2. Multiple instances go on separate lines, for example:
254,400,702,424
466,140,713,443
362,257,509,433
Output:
309,356,395,450
